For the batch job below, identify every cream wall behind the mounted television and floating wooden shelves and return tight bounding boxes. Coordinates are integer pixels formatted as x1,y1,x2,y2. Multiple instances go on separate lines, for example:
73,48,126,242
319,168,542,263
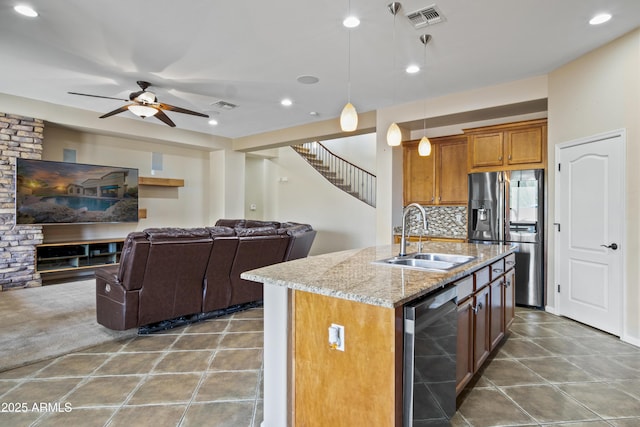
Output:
42,124,209,242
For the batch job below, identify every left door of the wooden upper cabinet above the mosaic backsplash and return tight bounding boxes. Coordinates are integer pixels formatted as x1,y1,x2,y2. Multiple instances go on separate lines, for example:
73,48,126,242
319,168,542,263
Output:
403,143,435,206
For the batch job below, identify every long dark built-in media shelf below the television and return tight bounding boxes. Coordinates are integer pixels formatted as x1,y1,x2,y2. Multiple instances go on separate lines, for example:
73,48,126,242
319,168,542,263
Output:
36,239,124,273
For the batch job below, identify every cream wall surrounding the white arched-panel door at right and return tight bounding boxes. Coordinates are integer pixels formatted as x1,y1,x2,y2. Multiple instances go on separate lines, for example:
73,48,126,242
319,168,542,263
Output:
547,29,640,345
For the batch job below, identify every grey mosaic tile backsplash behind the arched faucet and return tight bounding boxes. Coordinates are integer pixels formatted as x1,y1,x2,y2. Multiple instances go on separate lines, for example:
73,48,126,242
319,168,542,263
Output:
393,206,467,238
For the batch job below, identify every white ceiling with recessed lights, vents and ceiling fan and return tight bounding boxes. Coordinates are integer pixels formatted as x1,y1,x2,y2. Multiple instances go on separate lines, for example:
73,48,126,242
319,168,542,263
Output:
0,0,640,138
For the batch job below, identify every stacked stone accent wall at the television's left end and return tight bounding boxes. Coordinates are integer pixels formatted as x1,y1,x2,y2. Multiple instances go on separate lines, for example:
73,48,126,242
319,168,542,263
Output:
0,113,44,290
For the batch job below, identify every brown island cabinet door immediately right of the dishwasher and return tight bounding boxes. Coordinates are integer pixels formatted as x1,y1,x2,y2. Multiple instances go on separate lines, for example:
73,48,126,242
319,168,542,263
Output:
456,298,474,394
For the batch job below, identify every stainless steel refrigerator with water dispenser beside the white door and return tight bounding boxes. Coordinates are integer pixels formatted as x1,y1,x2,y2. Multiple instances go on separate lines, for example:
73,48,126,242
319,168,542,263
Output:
468,169,544,308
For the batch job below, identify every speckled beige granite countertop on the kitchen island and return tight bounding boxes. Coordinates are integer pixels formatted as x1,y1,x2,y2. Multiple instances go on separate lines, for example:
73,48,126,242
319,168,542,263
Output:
241,242,513,308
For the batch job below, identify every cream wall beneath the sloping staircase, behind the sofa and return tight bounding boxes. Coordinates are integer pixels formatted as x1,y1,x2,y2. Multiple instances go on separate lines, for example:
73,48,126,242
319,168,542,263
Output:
264,147,376,255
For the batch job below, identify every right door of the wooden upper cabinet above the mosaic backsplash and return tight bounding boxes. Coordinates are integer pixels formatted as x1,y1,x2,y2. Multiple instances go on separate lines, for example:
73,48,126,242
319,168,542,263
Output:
436,137,469,205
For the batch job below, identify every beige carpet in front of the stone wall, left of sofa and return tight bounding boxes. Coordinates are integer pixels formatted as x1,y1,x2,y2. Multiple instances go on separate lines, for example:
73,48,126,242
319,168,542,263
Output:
0,279,138,371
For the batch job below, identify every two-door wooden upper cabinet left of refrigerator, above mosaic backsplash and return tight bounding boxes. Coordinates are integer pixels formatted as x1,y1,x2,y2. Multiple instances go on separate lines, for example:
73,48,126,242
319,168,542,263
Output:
403,135,468,206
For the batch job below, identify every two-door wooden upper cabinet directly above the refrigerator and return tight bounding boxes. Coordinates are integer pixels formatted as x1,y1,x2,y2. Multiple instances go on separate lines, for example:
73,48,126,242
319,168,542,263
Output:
465,119,547,172
